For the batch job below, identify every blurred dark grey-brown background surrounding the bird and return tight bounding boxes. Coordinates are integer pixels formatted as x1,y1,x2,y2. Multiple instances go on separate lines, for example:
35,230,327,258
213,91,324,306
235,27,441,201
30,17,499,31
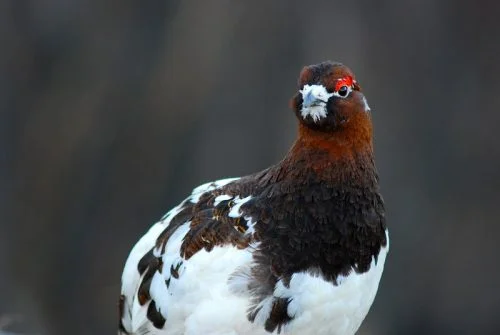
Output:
0,0,500,335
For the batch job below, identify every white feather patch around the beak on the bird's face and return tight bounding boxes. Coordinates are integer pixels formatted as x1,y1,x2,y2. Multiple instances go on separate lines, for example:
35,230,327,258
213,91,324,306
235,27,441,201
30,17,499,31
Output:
299,85,333,122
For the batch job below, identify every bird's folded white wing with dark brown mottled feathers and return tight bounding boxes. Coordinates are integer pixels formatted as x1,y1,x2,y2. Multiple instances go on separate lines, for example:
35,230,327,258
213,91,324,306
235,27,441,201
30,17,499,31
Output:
120,178,255,334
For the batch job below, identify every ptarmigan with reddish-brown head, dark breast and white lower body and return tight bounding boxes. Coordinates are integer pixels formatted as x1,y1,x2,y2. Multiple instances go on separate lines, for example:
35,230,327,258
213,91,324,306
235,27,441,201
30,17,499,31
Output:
118,61,389,335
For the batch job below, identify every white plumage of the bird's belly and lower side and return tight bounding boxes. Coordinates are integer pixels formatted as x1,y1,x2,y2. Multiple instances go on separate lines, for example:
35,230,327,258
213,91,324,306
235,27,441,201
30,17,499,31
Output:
122,215,389,335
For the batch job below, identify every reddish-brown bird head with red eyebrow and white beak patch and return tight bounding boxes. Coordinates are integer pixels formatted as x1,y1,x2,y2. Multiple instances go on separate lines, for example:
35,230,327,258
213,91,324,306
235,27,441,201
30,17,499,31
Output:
291,61,370,133
